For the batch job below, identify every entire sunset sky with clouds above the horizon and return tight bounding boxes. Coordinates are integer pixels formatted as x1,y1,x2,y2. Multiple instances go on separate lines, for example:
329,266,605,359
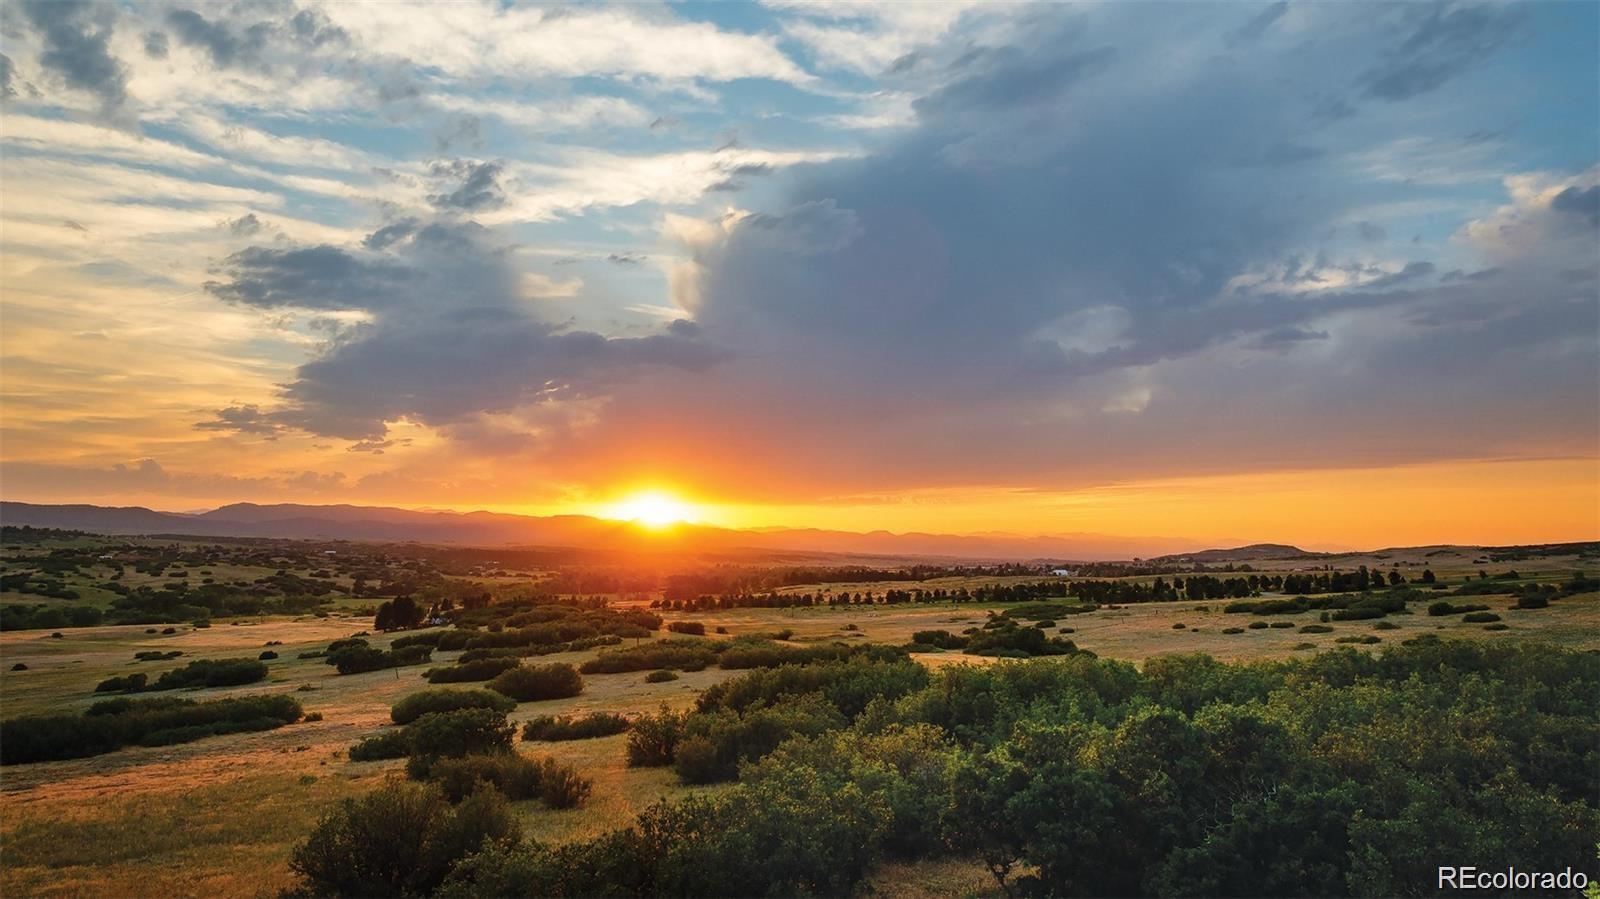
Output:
0,0,1600,547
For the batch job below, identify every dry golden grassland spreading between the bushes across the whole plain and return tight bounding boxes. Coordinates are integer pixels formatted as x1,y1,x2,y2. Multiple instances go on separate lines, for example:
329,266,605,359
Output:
0,527,1600,896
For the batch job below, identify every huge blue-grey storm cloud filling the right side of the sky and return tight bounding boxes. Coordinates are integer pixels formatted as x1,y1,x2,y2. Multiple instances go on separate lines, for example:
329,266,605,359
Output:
544,5,1597,493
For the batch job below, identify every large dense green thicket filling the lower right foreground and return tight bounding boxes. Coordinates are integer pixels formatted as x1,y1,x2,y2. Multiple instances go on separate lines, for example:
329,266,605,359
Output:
296,635,1600,897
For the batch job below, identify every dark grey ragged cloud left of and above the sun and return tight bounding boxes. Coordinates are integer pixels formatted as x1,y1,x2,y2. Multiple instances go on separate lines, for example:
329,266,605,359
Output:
206,222,725,445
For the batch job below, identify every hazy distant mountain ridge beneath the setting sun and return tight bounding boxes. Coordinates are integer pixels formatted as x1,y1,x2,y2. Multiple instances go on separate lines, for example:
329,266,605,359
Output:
0,502,1209,561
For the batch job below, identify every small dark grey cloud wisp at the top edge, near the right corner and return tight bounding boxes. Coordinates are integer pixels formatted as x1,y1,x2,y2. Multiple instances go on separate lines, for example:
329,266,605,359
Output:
1360,3,1525,101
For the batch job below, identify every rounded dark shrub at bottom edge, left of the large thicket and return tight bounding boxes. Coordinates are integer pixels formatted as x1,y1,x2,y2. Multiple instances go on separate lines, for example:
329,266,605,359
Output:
290,781,522,896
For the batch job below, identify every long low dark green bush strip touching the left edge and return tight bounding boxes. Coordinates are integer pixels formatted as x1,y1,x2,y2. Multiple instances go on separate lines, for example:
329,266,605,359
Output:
0,696,301,765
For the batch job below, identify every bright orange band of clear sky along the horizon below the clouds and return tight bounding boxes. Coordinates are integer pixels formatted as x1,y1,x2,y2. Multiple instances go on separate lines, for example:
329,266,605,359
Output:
5,459,1600,550
